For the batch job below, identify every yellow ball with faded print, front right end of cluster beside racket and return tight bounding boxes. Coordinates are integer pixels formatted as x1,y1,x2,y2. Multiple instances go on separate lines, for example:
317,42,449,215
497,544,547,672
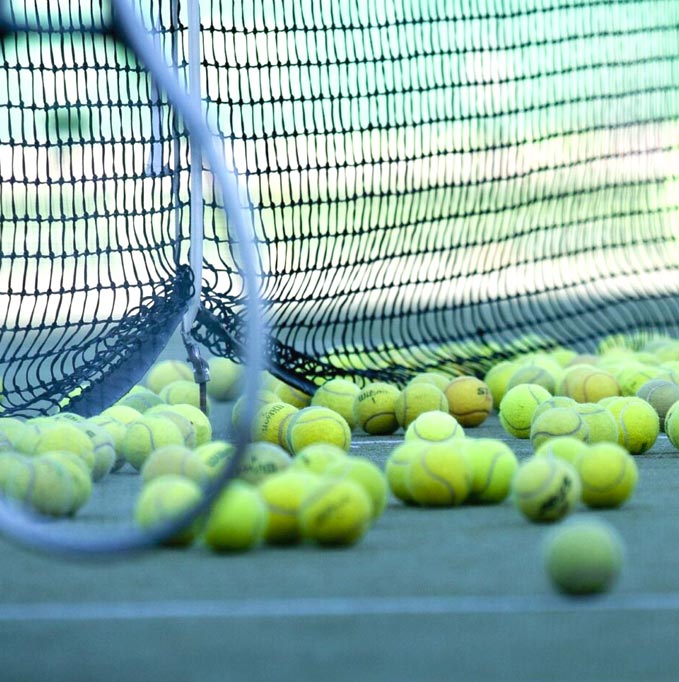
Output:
299,478,373,546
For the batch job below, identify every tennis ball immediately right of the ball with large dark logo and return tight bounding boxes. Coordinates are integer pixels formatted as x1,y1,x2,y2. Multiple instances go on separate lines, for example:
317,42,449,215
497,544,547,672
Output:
577,443,639,507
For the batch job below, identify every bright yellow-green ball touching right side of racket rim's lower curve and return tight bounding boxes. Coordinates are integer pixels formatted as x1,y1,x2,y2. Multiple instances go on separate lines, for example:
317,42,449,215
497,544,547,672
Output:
203,481,268,552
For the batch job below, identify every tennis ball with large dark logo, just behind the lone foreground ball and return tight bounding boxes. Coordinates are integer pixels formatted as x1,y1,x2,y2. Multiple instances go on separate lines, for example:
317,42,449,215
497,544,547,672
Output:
512,456,581,522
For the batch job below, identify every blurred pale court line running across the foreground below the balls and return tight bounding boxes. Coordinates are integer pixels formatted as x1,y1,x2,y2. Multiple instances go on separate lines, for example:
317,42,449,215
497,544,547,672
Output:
0,593,679,623
